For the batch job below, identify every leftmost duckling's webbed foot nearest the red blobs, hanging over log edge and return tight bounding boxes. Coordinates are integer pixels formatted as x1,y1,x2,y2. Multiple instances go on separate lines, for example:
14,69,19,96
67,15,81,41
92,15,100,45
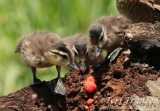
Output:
47,78,66,95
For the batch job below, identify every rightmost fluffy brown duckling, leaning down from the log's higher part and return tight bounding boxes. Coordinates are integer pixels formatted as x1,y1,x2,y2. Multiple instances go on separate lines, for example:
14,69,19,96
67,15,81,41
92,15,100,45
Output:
89,15,131,62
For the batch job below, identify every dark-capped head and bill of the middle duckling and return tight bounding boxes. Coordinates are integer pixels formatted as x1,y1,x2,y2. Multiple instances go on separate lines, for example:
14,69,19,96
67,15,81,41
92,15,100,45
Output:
72,41,88,73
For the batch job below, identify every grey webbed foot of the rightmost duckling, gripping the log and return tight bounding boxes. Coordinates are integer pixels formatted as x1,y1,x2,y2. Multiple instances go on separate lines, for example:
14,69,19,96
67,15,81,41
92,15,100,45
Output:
105,47,122,62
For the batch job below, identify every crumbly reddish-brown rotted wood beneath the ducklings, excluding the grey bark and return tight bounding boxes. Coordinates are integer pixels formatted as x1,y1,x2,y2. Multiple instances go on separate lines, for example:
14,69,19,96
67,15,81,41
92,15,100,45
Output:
0,23,160,111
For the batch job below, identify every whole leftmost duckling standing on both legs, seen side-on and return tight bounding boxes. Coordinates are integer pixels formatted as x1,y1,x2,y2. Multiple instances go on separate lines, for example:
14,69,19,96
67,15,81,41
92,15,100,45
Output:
15,32,78,95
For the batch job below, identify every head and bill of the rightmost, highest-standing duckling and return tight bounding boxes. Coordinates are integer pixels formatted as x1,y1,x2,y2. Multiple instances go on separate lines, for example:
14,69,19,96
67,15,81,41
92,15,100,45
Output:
89,25,107,58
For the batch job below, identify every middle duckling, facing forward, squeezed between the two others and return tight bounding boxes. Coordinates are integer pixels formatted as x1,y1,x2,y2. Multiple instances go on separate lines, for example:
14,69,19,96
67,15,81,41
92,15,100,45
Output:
63,33,104,73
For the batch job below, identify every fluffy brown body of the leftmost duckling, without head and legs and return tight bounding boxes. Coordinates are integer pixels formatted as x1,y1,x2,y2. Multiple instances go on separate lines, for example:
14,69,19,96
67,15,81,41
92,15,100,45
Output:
15,32,61,68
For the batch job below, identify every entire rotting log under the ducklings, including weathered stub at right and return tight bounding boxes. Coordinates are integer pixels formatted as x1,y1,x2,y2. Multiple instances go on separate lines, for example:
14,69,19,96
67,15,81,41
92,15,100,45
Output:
0,22,160,111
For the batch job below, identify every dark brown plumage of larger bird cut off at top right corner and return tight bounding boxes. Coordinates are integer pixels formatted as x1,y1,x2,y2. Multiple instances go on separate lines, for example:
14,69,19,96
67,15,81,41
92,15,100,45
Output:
117,0,160,23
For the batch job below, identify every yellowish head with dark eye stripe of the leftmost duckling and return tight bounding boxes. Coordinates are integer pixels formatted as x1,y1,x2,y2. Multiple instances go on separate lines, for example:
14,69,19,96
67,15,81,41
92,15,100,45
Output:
44,42,79,70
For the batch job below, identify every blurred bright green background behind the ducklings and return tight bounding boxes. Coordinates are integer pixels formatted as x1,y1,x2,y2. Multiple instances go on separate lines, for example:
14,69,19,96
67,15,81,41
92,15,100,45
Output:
0,0,118,96
